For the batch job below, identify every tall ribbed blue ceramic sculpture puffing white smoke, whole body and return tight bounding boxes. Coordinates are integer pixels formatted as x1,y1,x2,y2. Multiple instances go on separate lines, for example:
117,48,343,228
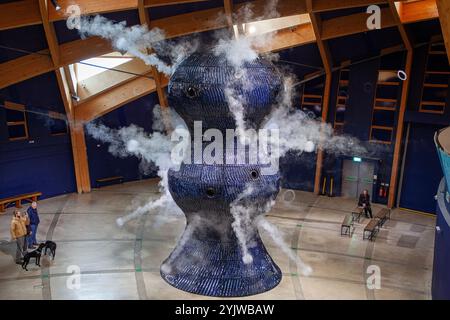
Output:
161,51,282,297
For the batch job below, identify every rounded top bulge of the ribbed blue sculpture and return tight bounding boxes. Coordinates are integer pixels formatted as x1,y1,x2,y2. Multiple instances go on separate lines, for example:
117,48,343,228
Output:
168,53,282,133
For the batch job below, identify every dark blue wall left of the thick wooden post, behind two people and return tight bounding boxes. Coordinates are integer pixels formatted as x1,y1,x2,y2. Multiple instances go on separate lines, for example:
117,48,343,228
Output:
0,73,76,198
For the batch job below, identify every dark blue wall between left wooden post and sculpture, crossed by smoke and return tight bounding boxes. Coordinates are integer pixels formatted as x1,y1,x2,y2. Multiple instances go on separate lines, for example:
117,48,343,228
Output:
86,93,158,187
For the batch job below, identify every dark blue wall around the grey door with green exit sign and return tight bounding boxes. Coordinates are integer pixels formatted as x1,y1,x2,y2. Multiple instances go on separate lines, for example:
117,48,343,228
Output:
321,54,404,203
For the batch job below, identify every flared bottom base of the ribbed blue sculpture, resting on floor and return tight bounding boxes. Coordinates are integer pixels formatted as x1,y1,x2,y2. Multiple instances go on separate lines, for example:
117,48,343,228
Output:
161,230,282,297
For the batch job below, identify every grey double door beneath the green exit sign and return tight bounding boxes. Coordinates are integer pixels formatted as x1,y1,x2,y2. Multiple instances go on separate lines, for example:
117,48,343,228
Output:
342,160,375,198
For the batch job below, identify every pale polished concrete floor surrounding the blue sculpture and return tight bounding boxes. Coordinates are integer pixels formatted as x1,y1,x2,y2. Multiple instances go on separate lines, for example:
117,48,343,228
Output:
0,180,435,299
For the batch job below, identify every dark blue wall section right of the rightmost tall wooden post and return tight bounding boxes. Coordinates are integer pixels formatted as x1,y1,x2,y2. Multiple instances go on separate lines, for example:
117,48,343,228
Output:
400,39,450,213
